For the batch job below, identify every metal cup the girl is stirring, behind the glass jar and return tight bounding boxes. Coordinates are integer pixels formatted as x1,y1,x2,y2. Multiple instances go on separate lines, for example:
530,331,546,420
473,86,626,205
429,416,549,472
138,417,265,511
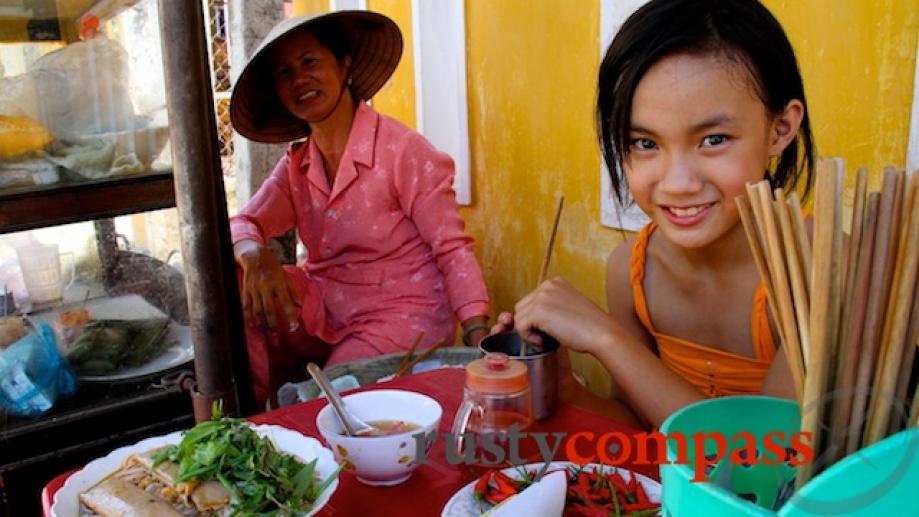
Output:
479,330,559,420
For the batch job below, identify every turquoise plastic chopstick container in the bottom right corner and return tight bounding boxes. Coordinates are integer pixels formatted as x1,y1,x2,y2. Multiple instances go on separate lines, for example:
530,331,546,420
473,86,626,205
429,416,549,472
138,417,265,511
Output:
661,396,919,517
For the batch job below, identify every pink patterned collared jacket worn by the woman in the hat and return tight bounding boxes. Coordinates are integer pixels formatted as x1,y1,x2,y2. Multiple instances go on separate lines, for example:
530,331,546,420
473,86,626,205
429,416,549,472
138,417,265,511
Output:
230,103,489,348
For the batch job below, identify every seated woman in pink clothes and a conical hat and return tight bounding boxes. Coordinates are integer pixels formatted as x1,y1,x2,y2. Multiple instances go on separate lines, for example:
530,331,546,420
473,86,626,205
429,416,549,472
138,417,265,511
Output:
230,11,489,401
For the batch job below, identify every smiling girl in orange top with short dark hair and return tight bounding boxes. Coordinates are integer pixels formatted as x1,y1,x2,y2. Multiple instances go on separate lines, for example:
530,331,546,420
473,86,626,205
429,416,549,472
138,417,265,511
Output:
498,0,814,426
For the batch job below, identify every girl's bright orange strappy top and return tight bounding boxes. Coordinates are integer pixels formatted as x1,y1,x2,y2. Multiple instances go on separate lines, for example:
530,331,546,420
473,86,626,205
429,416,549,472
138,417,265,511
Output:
630,223,776,397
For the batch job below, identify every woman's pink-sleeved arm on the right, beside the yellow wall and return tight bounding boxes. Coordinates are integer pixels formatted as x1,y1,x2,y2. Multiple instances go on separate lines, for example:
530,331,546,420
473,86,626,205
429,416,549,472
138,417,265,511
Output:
393,132,489,324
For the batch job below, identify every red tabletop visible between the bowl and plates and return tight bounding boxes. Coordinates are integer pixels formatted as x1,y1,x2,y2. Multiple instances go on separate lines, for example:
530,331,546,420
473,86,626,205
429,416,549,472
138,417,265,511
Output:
42,368,659,516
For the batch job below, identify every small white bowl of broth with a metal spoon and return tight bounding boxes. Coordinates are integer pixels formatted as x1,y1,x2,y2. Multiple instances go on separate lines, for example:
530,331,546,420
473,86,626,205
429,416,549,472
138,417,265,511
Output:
316,390,443,486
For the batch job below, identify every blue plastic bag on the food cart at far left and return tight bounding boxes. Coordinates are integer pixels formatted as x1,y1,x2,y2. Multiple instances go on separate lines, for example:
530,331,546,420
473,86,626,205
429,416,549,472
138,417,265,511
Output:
0,322,76,416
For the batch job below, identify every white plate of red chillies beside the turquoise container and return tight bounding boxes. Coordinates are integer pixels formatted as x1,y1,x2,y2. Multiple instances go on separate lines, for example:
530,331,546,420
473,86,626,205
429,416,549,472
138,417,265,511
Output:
441,461,661,517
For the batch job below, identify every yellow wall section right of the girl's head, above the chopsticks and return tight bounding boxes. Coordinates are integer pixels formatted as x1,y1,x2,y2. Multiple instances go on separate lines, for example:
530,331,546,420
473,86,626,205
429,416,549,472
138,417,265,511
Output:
764,0,919,189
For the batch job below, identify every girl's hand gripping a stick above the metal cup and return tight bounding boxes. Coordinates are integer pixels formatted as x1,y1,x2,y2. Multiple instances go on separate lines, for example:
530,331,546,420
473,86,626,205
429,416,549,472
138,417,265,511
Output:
512,277,613,353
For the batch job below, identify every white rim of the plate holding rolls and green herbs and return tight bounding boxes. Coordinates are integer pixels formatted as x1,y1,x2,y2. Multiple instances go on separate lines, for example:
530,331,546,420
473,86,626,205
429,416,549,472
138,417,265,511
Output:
51,425,338,517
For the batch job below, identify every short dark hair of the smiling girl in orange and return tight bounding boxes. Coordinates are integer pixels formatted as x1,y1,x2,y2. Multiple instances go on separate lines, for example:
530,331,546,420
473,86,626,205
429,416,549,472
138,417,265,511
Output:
596,0,815,203
